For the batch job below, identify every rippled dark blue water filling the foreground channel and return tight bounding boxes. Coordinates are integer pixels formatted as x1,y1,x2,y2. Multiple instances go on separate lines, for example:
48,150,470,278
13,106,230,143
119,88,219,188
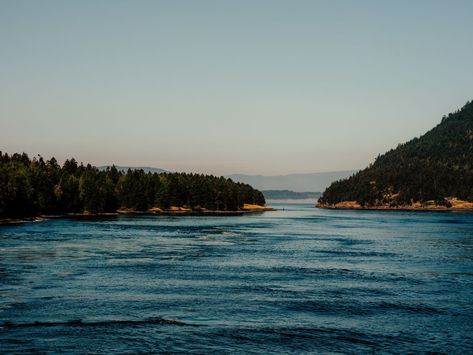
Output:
0,205,473,353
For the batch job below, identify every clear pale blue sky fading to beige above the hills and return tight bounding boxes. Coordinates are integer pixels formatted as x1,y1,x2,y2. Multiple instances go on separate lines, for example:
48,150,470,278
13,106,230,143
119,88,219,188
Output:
0,0,473,175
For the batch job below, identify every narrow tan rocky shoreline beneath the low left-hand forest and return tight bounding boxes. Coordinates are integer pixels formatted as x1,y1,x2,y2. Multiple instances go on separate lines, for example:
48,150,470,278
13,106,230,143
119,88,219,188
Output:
0,205,275,225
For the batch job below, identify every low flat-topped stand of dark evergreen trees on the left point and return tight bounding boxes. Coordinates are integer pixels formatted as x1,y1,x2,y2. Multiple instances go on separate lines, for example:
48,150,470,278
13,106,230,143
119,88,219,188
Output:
0,152,265,218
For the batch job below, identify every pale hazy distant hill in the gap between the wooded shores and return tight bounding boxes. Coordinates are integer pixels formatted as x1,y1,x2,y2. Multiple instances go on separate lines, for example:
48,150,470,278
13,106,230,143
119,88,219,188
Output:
226,170,355,192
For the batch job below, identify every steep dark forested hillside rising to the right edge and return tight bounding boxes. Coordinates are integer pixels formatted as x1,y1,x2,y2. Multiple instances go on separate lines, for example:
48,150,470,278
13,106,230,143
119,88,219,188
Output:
319,102,473,207
